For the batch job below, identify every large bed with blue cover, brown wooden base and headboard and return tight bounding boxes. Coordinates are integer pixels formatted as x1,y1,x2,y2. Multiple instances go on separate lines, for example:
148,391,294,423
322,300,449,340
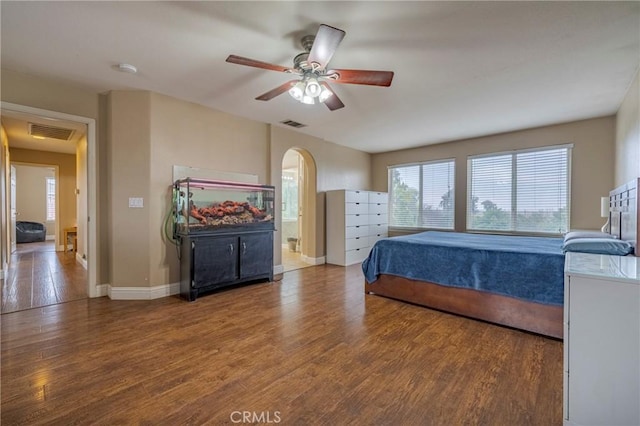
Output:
362,179,640,339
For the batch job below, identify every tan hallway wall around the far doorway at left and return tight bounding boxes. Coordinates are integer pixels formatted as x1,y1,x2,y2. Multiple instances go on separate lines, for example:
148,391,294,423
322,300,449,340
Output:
9,147,78,243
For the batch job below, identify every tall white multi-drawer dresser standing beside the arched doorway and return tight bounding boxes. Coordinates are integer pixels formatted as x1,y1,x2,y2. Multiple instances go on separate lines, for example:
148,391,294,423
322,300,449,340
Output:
325,189,388,266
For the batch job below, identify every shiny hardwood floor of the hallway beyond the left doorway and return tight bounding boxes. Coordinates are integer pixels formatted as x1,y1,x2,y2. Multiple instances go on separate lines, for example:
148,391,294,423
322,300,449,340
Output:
0,241,87,314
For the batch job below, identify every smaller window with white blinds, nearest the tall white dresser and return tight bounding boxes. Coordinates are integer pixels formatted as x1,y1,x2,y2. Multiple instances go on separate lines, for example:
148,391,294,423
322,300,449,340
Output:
389,160,455,229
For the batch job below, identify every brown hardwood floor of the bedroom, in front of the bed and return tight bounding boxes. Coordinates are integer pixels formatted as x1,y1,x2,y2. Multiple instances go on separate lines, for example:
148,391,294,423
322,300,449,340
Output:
0,265,562,425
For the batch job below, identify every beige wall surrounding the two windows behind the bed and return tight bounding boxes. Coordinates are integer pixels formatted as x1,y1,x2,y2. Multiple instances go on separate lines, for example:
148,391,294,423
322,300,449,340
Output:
372,117,615,232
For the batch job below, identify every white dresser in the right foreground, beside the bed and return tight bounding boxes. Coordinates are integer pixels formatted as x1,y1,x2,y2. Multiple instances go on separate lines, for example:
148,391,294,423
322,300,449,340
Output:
563,253,640,426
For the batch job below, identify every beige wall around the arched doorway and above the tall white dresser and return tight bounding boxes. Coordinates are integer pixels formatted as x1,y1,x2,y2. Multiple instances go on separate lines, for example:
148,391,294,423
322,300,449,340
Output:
271,126,371,264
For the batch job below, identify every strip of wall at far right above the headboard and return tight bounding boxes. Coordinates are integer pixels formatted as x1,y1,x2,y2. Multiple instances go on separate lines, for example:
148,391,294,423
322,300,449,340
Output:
615,72,640,186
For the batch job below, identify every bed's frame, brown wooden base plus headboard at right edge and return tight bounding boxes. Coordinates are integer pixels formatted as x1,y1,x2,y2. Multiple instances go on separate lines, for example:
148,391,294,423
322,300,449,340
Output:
364,179,640,339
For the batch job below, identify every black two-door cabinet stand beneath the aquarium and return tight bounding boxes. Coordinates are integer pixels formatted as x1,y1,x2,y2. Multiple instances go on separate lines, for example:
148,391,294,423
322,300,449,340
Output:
180,231,273,301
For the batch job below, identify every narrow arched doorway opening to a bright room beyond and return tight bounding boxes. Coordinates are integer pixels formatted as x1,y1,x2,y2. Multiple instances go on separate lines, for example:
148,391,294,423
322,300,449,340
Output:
280,148,315,272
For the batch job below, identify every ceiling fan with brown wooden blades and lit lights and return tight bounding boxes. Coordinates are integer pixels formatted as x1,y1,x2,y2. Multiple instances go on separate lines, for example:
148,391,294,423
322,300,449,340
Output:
227,24,393,111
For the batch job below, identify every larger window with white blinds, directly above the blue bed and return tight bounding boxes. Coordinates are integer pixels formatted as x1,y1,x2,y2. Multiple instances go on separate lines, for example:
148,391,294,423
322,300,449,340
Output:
467,145,571,234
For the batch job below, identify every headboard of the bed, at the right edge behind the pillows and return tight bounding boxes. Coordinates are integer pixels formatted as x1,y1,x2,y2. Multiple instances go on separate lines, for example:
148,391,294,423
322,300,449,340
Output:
609,178,640,256
